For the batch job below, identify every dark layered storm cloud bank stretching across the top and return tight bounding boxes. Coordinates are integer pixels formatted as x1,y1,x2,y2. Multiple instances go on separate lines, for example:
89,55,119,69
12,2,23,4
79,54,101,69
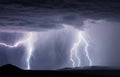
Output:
0,0,120,30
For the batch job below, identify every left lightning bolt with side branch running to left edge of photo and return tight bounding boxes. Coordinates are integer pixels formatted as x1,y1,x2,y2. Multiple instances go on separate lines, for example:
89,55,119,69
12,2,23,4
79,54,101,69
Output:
0,32,35,70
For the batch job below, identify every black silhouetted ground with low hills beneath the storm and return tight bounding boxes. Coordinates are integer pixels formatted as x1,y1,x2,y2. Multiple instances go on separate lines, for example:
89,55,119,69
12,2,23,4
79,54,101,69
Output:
0,65,120,77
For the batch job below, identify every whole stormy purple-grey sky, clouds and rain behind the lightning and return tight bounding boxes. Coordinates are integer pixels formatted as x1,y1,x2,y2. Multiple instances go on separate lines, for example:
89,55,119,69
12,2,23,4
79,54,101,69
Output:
0,0,120,70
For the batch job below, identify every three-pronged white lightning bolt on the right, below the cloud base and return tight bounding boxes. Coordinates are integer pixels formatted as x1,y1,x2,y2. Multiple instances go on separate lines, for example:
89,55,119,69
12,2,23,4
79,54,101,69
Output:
70,31,92,67
